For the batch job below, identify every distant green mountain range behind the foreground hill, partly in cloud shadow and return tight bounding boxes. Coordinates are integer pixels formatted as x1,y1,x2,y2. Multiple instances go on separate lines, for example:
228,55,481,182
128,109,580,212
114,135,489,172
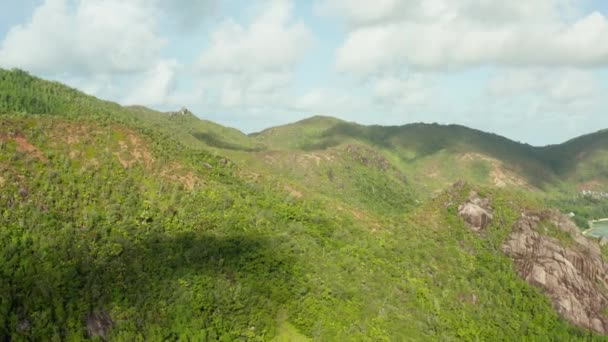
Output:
248,117,608,192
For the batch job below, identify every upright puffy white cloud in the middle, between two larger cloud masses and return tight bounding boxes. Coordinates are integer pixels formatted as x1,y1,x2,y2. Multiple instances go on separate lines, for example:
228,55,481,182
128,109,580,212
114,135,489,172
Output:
198,0,313,111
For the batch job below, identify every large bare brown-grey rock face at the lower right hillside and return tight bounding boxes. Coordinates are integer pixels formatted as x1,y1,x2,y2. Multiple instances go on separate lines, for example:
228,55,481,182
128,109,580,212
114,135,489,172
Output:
502,211,608,334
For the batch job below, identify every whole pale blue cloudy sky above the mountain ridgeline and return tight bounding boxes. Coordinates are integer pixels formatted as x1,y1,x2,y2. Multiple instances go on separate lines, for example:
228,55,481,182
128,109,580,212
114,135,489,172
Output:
0,0,608,145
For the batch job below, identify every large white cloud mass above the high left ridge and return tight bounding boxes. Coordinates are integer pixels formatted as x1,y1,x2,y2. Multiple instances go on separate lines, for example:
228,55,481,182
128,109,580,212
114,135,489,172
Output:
0,0,222,108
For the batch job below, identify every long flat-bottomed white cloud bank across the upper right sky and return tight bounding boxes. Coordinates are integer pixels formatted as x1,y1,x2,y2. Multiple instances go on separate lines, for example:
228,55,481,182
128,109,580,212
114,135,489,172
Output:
325,0,608,75
